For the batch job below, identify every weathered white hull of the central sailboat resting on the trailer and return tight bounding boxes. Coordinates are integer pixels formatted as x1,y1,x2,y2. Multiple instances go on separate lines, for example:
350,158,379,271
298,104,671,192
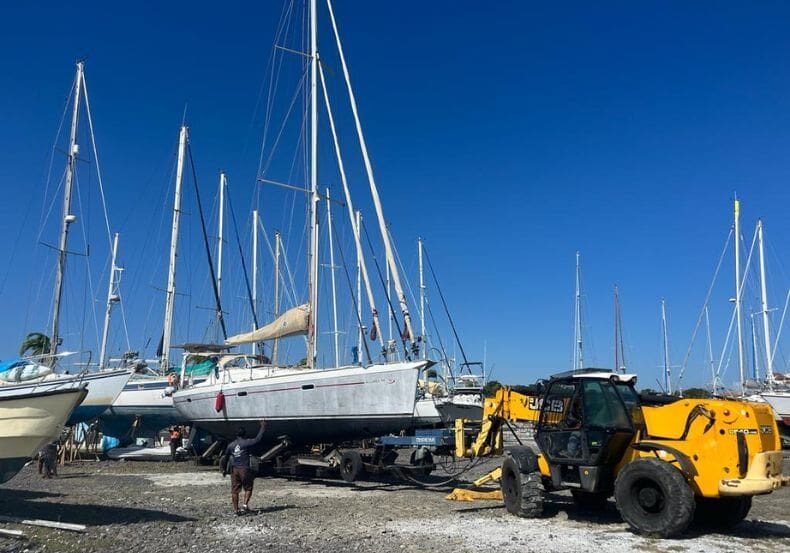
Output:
173,361,429,445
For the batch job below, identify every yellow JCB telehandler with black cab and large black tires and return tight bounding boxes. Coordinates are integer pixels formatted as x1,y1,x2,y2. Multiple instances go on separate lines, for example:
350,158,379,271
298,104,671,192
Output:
449,369,788,537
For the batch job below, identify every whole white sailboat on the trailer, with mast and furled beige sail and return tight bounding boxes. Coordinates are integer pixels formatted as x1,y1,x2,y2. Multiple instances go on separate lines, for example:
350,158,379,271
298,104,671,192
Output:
173,0,433,445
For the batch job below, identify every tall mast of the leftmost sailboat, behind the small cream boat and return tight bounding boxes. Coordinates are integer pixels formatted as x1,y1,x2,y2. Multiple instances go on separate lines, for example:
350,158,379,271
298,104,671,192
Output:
49,61,84,355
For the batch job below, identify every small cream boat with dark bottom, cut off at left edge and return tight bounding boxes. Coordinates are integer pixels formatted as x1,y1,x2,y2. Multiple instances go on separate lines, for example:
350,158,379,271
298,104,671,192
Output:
0,384,88,483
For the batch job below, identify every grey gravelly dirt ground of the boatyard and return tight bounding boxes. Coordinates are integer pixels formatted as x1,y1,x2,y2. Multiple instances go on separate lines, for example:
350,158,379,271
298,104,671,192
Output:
0,452,790,553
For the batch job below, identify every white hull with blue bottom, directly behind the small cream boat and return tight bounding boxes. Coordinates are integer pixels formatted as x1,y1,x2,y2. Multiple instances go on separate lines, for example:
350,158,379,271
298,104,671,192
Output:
0,369,132,425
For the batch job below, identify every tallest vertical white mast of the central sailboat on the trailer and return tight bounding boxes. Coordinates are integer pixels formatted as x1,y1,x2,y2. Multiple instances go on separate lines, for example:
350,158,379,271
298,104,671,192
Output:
307,0,318,369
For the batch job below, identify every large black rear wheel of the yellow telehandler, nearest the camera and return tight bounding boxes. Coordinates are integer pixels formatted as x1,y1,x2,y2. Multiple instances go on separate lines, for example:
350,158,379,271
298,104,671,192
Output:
614,459,695,538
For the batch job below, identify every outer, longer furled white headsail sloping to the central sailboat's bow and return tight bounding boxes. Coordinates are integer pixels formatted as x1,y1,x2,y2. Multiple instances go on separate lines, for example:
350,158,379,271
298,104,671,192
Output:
326,0,414,340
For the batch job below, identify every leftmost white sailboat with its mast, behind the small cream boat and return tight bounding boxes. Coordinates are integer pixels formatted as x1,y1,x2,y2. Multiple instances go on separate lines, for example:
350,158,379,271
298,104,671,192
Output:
0,61,132,425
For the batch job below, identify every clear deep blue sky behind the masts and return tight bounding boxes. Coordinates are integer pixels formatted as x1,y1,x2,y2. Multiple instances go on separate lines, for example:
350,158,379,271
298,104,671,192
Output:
0,1,790,385
